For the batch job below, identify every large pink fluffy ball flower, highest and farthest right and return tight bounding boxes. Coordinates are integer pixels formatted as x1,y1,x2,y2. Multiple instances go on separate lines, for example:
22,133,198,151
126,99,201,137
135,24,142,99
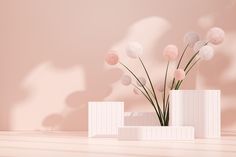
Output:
207,27,225,45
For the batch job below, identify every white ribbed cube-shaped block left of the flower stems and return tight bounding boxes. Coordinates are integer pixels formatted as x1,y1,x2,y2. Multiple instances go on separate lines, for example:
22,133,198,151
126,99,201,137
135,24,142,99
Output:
88,102,124,137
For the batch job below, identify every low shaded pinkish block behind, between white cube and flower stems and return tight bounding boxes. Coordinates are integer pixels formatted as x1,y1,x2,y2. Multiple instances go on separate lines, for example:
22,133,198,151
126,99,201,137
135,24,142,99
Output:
124,112,159,126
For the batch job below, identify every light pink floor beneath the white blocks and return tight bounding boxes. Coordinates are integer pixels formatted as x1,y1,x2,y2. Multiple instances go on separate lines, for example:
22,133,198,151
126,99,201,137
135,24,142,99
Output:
0,132,236,157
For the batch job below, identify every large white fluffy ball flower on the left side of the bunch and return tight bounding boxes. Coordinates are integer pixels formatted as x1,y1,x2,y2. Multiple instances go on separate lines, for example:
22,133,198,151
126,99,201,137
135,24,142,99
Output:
126,42,143,58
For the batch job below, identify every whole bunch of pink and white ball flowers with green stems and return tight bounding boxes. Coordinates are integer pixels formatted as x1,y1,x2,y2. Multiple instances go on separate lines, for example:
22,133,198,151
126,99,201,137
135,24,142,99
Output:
105,27,225,126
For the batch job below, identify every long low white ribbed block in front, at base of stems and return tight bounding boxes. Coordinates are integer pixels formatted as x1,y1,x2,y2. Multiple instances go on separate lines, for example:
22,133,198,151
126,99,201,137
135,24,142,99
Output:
118,126,194,140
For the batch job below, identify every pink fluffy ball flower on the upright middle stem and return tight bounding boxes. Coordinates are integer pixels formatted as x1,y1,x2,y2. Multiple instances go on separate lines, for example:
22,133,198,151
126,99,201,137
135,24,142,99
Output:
163,45,178,60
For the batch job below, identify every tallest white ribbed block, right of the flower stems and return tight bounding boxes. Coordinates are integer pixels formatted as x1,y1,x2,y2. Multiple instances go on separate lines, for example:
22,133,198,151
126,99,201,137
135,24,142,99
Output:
170,90,221,138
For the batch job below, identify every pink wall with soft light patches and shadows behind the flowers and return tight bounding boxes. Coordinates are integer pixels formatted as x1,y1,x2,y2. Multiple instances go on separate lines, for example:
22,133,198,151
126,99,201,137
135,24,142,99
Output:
0,0,236,131
